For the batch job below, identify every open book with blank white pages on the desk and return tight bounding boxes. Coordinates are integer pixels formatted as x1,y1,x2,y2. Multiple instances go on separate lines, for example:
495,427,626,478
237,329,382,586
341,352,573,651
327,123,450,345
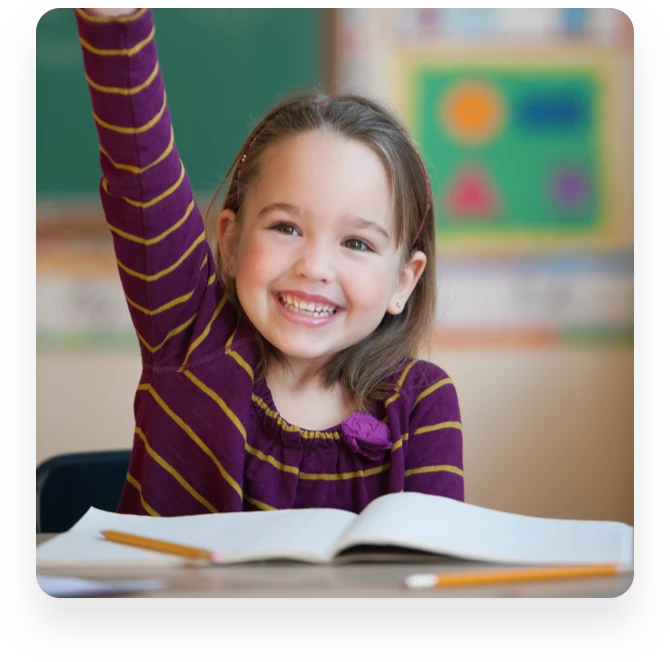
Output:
36,492,633,572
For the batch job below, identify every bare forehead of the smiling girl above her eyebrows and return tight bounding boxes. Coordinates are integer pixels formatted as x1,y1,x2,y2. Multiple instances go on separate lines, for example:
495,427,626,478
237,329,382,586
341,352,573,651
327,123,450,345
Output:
253,131,393,230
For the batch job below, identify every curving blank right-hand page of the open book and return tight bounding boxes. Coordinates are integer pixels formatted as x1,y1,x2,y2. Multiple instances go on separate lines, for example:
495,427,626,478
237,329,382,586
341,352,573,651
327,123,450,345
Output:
335,492,633,567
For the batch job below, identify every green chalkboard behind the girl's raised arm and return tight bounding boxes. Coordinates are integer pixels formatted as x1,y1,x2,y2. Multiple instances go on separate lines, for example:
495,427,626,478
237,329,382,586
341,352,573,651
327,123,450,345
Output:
36,7,325,201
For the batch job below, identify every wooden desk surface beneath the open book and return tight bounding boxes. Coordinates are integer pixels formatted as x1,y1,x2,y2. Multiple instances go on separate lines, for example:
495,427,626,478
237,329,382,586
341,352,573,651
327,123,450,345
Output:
36,534,633,598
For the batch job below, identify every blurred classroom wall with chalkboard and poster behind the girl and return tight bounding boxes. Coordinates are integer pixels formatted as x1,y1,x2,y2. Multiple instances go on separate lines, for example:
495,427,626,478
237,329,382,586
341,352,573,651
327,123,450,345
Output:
36,8,634,524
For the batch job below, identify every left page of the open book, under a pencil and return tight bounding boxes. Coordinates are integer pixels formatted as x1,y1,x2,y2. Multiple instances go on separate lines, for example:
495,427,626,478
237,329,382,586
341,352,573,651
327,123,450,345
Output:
36,508,356,568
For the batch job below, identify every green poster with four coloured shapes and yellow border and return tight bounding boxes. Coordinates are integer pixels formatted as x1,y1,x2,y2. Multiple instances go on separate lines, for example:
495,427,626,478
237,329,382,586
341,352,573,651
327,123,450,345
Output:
406,61,622,253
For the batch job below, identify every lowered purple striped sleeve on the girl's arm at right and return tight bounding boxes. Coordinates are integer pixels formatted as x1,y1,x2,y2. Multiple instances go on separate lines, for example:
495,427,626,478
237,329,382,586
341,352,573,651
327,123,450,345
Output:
404,365,465,501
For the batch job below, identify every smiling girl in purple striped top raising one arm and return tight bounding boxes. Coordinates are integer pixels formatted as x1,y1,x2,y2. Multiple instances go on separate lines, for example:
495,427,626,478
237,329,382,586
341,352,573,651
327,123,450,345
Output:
75,9,464,516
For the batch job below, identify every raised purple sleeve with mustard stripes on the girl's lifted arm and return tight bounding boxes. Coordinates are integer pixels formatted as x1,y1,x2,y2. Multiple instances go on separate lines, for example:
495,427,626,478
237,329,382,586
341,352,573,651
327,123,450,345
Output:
75,9,234,367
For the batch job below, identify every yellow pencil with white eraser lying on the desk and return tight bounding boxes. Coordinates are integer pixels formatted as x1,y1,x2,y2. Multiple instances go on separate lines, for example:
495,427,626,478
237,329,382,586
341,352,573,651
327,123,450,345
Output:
405,564,620,588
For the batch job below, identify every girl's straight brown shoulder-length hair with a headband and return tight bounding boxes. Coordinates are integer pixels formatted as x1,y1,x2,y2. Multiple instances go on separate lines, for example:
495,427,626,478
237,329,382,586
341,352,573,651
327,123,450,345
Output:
206,92,437,410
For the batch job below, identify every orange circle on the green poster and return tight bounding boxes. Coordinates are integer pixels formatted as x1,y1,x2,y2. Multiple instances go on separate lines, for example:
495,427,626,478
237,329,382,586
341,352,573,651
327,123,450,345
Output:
441,82,505,143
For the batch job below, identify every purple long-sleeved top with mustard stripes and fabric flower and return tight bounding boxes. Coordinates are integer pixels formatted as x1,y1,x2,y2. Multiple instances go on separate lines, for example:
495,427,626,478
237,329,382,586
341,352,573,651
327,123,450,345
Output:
75,9,464,516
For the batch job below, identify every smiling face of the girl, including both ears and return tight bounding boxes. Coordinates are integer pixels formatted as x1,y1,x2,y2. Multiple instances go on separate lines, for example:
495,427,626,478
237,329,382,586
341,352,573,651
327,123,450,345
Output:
219,131,425,363
